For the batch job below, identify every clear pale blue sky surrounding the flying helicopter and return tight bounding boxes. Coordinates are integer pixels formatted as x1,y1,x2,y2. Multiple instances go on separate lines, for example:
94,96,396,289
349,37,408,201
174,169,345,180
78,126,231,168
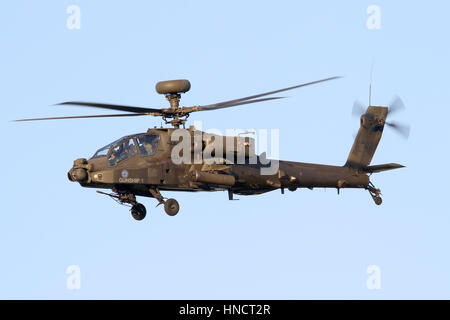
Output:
0,0,450,299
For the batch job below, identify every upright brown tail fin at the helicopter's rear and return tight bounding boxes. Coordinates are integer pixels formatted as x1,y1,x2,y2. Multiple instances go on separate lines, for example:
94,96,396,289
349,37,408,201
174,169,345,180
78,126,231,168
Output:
345,106,388,168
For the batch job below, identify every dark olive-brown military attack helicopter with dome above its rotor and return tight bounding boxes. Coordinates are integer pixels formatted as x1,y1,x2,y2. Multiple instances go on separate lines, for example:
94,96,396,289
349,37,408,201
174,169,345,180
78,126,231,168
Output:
15,77,409,220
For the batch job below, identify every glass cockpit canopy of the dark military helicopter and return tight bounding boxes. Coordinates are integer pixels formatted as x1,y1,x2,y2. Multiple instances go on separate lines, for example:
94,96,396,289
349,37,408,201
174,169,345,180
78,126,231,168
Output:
91,133,160,166
